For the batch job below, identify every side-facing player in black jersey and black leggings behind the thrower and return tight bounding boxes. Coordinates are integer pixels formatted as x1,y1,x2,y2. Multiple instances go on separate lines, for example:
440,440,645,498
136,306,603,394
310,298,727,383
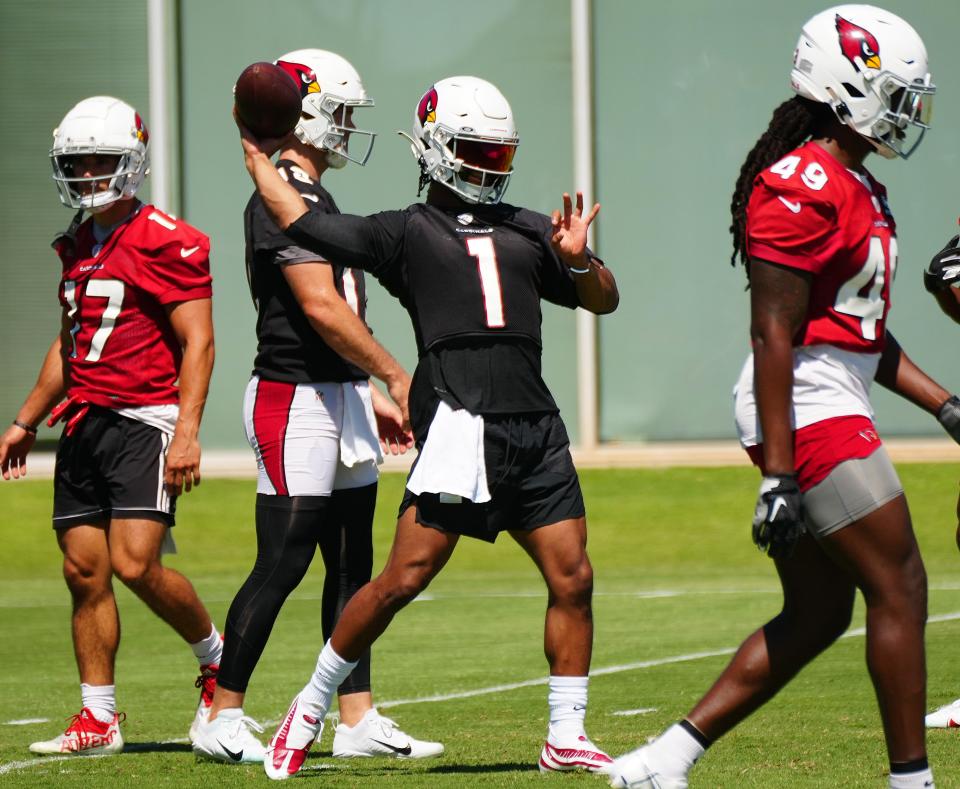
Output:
191,49,443,763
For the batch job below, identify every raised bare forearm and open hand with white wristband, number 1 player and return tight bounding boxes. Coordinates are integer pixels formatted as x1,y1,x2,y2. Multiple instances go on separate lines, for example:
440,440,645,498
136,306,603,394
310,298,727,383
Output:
550,192,620,315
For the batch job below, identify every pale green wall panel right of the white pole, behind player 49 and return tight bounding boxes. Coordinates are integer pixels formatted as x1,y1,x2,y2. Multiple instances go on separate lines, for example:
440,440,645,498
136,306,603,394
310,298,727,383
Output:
594,0,960,440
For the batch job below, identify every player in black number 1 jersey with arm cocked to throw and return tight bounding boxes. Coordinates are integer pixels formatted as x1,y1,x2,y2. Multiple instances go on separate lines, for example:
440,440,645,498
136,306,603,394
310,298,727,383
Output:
241,77,618,778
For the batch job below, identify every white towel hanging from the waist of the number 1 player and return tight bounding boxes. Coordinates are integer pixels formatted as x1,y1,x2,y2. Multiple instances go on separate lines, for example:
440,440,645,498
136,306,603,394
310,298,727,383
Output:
407,400,490,504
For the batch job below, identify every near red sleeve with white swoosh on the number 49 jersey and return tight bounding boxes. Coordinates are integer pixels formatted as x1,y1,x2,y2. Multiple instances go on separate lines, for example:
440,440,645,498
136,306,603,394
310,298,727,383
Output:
747,173,837,273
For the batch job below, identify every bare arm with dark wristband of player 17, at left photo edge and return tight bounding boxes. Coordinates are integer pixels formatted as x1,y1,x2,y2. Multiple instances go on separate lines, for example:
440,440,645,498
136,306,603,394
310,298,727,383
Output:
0,314,70,479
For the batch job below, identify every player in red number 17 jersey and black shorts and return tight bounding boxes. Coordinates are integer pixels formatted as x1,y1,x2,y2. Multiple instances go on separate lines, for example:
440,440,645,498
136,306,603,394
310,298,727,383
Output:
0,96,221,754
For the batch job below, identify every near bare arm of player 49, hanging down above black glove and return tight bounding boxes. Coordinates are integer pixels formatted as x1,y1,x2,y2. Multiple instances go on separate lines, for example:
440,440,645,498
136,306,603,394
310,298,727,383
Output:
750,259,810,475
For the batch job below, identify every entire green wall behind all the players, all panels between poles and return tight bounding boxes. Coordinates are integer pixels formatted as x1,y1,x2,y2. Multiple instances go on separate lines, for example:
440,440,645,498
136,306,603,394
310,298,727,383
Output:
0,0,960,448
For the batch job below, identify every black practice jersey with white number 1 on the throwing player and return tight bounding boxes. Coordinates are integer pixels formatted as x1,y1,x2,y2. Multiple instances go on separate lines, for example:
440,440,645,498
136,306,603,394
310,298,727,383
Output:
287,195,580,431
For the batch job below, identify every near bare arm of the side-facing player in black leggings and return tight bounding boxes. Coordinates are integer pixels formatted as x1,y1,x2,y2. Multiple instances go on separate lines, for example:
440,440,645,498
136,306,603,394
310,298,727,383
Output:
283,261,410,424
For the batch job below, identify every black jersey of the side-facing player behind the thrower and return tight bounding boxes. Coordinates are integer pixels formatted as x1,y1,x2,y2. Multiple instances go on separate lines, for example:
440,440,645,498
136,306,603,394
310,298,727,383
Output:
243,160,368,383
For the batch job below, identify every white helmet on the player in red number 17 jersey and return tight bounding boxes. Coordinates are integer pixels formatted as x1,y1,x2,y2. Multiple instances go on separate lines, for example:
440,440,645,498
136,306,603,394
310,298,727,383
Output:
50,96,150,214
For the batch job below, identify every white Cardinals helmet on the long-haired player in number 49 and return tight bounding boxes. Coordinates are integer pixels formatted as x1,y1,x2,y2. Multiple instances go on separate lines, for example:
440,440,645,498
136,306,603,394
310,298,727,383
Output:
790,5,936,159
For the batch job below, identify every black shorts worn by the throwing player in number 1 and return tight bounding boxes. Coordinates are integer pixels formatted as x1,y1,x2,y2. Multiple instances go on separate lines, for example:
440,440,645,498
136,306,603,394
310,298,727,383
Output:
400,414,585,542
